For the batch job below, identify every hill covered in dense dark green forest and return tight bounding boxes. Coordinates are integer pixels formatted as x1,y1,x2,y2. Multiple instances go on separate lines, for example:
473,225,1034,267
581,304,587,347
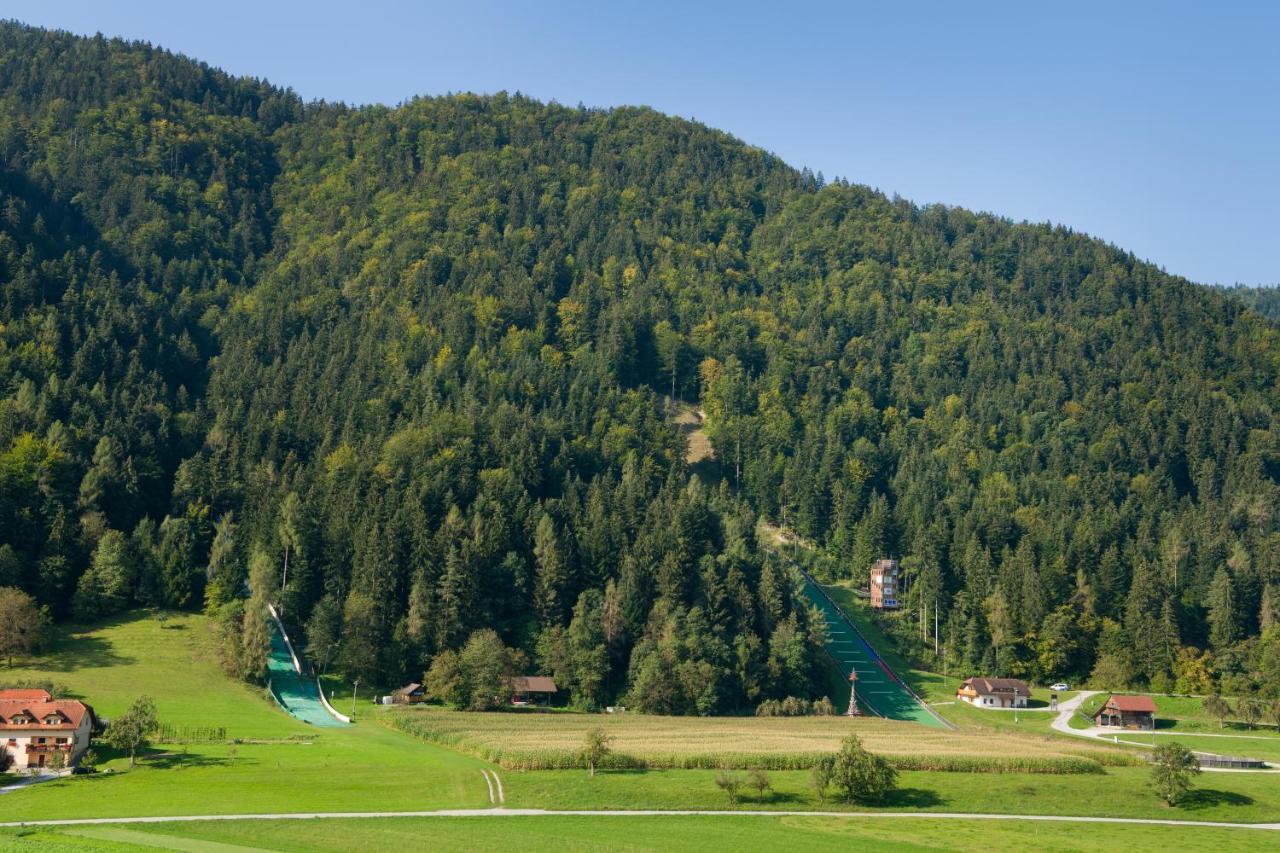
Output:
0,24,1280,713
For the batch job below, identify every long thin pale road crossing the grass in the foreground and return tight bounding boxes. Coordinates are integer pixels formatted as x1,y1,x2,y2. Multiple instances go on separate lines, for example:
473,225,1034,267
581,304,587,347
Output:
0,808,1280,831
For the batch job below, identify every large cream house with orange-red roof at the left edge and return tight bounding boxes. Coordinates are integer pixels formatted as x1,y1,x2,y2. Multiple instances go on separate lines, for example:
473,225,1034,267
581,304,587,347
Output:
0,690,93,770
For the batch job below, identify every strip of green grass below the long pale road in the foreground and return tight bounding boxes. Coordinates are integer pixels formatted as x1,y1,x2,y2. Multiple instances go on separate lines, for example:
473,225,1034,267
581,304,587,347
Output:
12,816,1275,853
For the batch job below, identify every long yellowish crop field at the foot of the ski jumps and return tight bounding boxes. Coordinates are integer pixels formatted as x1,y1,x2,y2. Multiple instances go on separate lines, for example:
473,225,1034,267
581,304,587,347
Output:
385,707,1138,774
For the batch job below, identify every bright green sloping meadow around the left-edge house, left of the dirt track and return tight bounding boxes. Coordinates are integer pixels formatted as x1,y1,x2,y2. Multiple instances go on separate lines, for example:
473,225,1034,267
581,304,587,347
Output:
0,615,488,820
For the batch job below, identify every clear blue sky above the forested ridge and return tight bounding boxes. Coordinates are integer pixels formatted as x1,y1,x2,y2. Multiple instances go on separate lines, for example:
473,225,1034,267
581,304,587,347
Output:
12,0,1280,284
